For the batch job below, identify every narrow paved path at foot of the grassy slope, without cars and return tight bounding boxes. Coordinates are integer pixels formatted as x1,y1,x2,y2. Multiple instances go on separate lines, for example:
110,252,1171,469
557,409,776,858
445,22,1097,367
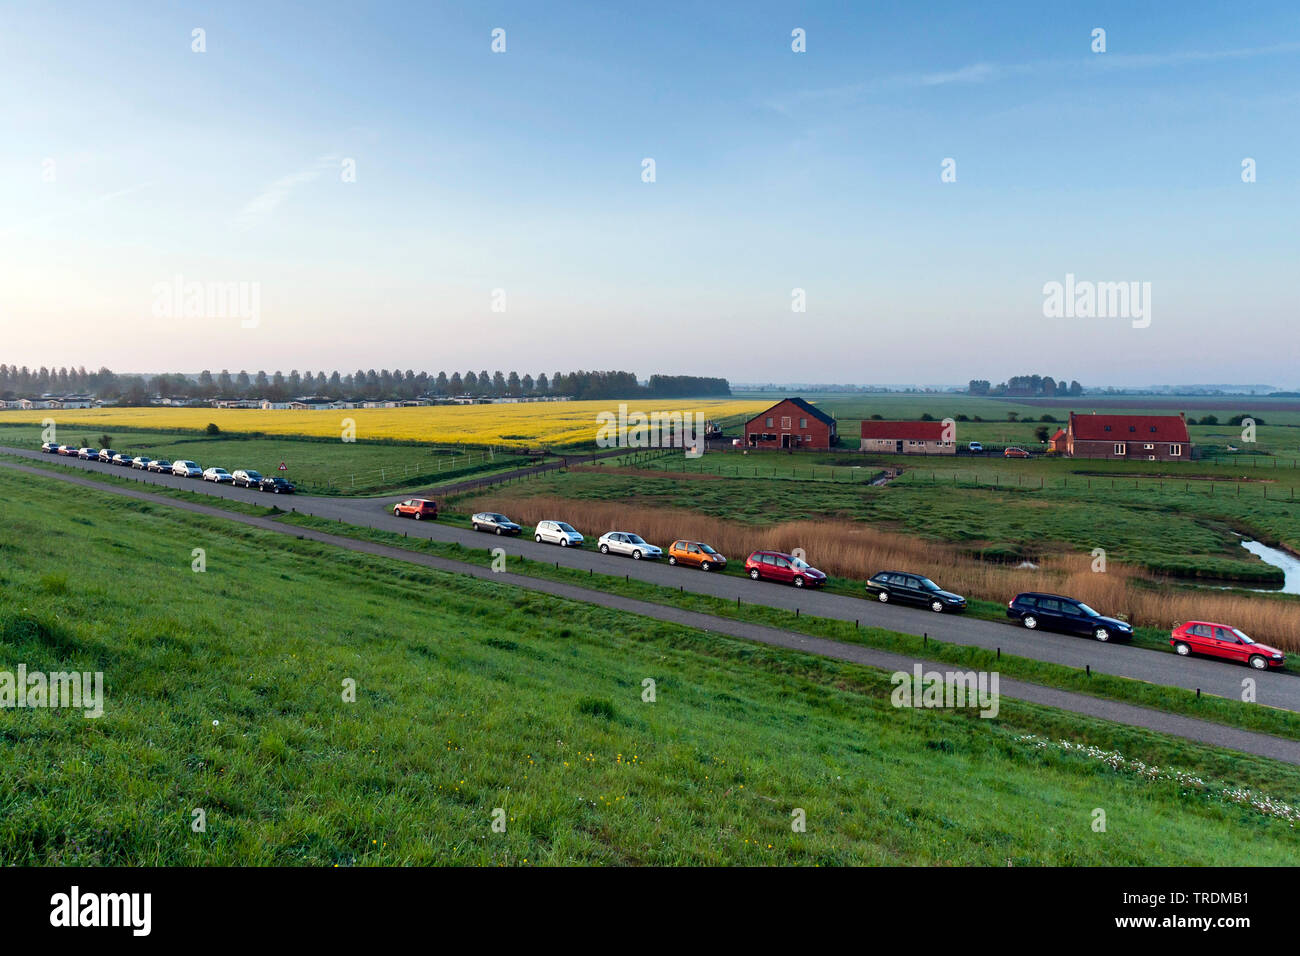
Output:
0,452,1300,765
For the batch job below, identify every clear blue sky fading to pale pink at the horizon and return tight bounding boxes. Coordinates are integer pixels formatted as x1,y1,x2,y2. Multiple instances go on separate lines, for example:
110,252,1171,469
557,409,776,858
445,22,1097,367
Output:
0,0,1300,388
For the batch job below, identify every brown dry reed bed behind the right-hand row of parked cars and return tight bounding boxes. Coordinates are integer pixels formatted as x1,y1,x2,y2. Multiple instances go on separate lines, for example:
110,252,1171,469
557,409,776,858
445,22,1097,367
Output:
458,493,1300,652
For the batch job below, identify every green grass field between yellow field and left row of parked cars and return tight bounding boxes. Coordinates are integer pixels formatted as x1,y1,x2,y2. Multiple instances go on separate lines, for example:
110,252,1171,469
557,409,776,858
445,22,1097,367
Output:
0,425,533,494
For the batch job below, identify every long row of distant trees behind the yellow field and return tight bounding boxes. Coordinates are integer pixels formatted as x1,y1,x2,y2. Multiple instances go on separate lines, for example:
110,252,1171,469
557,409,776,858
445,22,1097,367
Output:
0,364,731,405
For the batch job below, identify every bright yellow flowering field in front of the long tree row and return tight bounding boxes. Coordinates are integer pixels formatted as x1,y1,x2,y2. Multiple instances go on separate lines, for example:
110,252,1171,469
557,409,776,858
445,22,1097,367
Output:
0,398,771,446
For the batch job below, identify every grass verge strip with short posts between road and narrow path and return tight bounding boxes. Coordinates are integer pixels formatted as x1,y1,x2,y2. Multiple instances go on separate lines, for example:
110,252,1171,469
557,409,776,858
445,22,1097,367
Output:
280,514,1300,740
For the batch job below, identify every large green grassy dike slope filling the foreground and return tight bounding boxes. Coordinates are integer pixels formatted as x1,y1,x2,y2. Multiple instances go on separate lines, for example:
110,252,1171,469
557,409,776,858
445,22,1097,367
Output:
0,472,1300,865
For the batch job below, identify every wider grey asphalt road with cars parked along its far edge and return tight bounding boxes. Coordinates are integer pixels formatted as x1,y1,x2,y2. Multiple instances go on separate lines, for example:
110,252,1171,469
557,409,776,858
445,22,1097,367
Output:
10,447,1300,711
